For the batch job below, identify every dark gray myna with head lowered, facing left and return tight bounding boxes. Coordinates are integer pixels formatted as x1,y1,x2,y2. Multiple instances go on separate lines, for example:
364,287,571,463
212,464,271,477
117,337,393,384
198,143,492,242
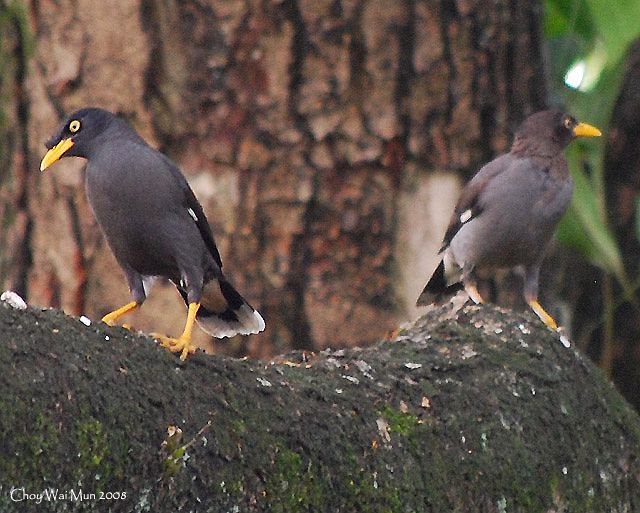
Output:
40,108,264,359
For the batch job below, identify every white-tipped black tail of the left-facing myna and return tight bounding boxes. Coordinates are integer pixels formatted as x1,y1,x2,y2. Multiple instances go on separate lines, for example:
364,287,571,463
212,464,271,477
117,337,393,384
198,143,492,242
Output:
178,278,264,338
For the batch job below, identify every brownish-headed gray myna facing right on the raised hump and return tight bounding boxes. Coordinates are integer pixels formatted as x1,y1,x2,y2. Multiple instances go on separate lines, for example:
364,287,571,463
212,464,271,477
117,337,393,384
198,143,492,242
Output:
417,110,600,330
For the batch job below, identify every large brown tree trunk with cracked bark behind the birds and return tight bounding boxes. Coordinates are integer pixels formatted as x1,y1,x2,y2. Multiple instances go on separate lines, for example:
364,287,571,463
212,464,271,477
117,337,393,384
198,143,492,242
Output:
0,0,545,356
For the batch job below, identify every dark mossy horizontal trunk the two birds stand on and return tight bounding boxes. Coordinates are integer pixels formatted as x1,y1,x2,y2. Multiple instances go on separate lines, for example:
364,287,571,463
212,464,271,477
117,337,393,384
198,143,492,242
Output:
0,305,640,513
